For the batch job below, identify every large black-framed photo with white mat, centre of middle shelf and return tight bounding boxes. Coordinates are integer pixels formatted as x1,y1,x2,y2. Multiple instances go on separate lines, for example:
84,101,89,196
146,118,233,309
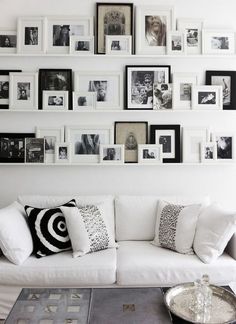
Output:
125,65,171,110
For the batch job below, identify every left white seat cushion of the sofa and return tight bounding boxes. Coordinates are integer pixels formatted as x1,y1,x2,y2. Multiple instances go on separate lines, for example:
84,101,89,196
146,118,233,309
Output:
0,248,116,287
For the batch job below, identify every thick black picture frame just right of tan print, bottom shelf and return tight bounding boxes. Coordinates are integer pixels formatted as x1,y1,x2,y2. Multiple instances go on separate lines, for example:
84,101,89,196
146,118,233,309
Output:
150,125,181,163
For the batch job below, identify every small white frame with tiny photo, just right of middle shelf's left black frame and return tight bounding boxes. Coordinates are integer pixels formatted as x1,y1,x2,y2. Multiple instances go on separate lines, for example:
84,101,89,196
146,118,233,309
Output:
73,91,97,110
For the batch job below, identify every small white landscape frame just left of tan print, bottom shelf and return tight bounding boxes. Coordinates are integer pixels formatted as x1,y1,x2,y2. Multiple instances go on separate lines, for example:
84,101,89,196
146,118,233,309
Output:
100,144,124,164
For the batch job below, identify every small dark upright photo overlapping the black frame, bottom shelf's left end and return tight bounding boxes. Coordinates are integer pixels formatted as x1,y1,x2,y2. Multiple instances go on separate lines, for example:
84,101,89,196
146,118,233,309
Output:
25,137,45,163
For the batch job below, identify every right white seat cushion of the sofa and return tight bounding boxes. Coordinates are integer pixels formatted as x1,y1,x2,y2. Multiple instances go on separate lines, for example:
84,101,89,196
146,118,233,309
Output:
117,241,236,287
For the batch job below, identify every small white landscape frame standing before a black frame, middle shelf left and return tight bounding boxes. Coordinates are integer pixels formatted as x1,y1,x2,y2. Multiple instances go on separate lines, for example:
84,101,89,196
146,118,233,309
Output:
43,90,68,111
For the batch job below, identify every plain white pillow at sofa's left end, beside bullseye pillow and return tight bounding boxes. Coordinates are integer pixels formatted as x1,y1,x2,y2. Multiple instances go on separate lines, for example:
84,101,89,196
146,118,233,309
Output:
0,201,33,265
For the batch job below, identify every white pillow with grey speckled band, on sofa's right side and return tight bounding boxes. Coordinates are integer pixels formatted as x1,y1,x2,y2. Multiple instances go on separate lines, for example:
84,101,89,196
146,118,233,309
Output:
151,200,201,254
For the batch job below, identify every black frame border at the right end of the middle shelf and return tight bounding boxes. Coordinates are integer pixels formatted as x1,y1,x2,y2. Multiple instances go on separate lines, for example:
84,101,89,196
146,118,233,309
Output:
206,70,236,110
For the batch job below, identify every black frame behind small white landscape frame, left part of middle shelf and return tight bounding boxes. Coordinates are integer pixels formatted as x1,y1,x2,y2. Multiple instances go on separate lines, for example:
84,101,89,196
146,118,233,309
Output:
38,69,73,110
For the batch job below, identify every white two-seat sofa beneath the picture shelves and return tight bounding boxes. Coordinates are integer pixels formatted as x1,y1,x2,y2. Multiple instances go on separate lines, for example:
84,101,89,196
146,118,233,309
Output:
0,196,236,318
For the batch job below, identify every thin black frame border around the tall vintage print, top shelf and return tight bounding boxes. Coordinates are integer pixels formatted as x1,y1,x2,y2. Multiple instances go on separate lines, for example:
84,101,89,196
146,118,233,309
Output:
95,2,135,54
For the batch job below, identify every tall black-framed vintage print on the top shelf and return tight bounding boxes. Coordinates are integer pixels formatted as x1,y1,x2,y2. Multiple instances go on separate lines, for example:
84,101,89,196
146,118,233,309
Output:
95,2,135,54
